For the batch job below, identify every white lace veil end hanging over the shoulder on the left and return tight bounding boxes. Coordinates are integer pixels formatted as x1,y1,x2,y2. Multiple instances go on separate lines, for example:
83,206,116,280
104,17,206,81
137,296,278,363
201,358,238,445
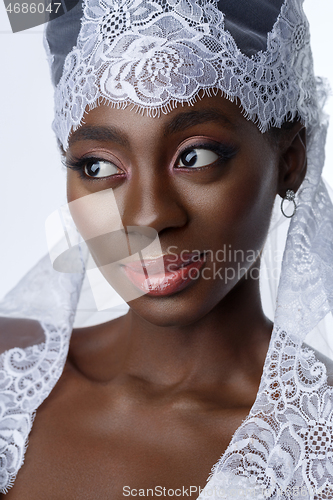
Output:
0,256,82,493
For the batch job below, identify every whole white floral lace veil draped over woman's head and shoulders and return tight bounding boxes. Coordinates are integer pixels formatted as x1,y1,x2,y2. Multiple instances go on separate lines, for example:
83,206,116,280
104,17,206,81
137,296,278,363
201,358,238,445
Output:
0,0,333,500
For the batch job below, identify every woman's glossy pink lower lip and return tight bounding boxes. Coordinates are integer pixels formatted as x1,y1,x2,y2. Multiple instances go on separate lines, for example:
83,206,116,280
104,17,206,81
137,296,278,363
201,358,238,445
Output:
122,256,205,297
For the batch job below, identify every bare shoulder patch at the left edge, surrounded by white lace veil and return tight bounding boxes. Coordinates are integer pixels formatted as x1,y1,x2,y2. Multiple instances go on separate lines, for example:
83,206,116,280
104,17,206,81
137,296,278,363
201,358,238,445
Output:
0,317,45,354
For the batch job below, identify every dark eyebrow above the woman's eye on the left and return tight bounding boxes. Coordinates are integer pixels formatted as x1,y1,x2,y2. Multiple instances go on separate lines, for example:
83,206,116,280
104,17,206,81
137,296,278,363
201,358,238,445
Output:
68,125,129,148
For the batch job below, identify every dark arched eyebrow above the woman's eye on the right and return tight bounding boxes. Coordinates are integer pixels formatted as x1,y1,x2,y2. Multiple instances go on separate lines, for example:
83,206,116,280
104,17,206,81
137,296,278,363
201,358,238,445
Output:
164,109,234,135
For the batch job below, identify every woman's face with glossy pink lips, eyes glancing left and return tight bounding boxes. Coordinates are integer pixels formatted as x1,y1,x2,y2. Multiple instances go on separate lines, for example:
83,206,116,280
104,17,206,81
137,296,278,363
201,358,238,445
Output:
66,96,280,326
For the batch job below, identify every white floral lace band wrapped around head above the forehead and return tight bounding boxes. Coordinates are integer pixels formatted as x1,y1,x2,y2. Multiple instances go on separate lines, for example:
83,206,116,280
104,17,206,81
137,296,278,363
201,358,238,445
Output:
53,0,317,149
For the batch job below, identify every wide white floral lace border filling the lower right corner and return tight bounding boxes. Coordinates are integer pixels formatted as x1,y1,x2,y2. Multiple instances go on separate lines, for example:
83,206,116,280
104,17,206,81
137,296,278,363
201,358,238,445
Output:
199,328,333,500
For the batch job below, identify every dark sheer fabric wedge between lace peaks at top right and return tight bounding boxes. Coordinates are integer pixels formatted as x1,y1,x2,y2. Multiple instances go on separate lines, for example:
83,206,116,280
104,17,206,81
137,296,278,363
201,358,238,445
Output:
218,0,284,57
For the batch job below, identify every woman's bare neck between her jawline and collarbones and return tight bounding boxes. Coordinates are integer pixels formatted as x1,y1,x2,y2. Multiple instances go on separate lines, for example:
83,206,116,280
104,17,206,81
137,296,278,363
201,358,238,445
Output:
118,274,272,389
